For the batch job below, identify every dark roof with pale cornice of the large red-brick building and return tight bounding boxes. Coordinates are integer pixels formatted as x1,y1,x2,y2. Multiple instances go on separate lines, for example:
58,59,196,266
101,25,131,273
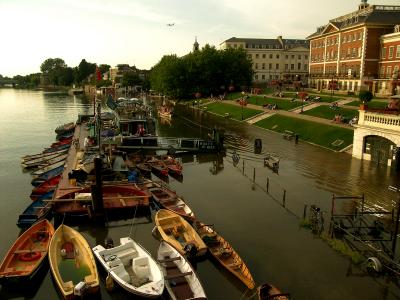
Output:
307,5,400,39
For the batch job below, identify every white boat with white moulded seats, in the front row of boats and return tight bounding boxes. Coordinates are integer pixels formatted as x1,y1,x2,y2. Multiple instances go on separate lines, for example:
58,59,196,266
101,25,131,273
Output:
93,237,164,298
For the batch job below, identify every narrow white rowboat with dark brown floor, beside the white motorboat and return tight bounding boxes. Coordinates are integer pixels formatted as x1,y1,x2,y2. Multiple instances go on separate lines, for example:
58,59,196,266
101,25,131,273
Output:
157,241,207,300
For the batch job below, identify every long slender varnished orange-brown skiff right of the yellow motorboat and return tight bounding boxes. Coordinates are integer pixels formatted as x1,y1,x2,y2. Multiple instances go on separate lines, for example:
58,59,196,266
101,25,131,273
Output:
195,222,255,289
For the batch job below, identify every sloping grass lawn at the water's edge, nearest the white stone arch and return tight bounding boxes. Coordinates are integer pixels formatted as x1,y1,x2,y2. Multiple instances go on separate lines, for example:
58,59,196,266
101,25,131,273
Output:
255,114,353,150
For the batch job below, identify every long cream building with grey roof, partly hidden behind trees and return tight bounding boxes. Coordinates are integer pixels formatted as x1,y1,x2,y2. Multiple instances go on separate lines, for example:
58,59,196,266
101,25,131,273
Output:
220,36,309,83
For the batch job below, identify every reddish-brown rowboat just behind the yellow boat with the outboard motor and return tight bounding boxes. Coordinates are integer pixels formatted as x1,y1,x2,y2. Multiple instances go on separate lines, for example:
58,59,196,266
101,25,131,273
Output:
149,183,195,221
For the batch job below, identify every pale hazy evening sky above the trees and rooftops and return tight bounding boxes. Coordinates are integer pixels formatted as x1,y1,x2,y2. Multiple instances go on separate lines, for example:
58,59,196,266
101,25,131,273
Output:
0,0,400,77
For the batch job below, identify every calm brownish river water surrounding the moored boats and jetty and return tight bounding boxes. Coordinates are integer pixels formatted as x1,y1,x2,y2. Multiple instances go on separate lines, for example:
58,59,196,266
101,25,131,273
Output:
0,89,400,299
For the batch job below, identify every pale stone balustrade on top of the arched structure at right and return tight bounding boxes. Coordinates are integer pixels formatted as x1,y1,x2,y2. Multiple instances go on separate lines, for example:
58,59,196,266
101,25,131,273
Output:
358,110,400,132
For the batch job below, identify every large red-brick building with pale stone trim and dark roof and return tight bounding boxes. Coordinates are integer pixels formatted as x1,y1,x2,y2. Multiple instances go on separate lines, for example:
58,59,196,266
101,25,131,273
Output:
307,0,400,93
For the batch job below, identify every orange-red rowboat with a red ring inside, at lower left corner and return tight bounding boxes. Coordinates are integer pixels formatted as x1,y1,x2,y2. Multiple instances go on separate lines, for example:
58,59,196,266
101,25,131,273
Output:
0,219,54,280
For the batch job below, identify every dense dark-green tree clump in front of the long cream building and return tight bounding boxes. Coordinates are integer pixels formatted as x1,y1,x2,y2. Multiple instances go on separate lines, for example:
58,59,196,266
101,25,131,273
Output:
150,45,253,98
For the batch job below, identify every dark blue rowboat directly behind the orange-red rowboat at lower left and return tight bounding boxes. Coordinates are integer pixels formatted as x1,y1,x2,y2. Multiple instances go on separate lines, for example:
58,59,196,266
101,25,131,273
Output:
17,199,52,228
